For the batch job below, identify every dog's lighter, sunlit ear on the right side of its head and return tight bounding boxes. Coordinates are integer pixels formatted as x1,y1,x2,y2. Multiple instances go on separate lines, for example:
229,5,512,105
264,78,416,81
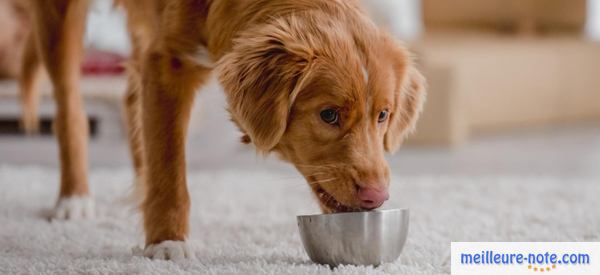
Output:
384,64,426,153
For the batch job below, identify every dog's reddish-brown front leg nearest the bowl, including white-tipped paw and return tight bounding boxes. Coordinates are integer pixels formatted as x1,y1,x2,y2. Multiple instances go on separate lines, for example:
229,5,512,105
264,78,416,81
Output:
142,49,209,260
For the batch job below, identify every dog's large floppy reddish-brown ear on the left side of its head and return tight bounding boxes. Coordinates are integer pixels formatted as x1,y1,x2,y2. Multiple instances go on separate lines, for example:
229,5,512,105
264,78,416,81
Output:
217,22,312,152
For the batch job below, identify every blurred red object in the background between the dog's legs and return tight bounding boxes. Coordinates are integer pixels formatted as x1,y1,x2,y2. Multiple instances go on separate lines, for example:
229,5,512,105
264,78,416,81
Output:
81,49,126,75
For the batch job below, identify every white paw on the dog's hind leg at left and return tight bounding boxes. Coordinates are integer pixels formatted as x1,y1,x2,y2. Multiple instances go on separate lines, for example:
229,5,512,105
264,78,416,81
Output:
52,196,95,220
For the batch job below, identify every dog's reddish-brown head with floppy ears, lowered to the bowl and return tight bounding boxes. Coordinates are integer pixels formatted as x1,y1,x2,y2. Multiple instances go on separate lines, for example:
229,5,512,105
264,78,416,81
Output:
219,10,425,213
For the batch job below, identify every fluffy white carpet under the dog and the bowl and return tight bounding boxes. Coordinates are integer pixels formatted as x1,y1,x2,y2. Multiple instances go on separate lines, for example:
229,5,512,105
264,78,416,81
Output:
0,167,600,274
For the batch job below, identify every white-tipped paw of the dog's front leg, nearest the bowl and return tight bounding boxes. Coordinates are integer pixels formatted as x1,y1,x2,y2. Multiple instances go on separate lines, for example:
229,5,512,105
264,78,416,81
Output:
141,241,196,261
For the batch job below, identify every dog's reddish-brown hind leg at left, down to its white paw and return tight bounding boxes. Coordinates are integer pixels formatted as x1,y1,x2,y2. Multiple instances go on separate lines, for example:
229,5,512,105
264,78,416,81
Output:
32,0,94,219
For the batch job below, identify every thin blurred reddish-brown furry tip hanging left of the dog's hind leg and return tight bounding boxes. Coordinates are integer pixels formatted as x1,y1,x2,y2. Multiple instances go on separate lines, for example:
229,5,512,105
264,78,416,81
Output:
19,34,41,135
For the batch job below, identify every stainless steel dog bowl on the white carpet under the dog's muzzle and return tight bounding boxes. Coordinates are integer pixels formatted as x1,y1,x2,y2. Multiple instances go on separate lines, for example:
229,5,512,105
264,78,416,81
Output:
297,209,409,266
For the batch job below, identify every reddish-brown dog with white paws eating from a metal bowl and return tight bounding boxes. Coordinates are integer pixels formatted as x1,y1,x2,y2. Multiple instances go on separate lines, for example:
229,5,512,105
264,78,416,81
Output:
22,0,425,259
